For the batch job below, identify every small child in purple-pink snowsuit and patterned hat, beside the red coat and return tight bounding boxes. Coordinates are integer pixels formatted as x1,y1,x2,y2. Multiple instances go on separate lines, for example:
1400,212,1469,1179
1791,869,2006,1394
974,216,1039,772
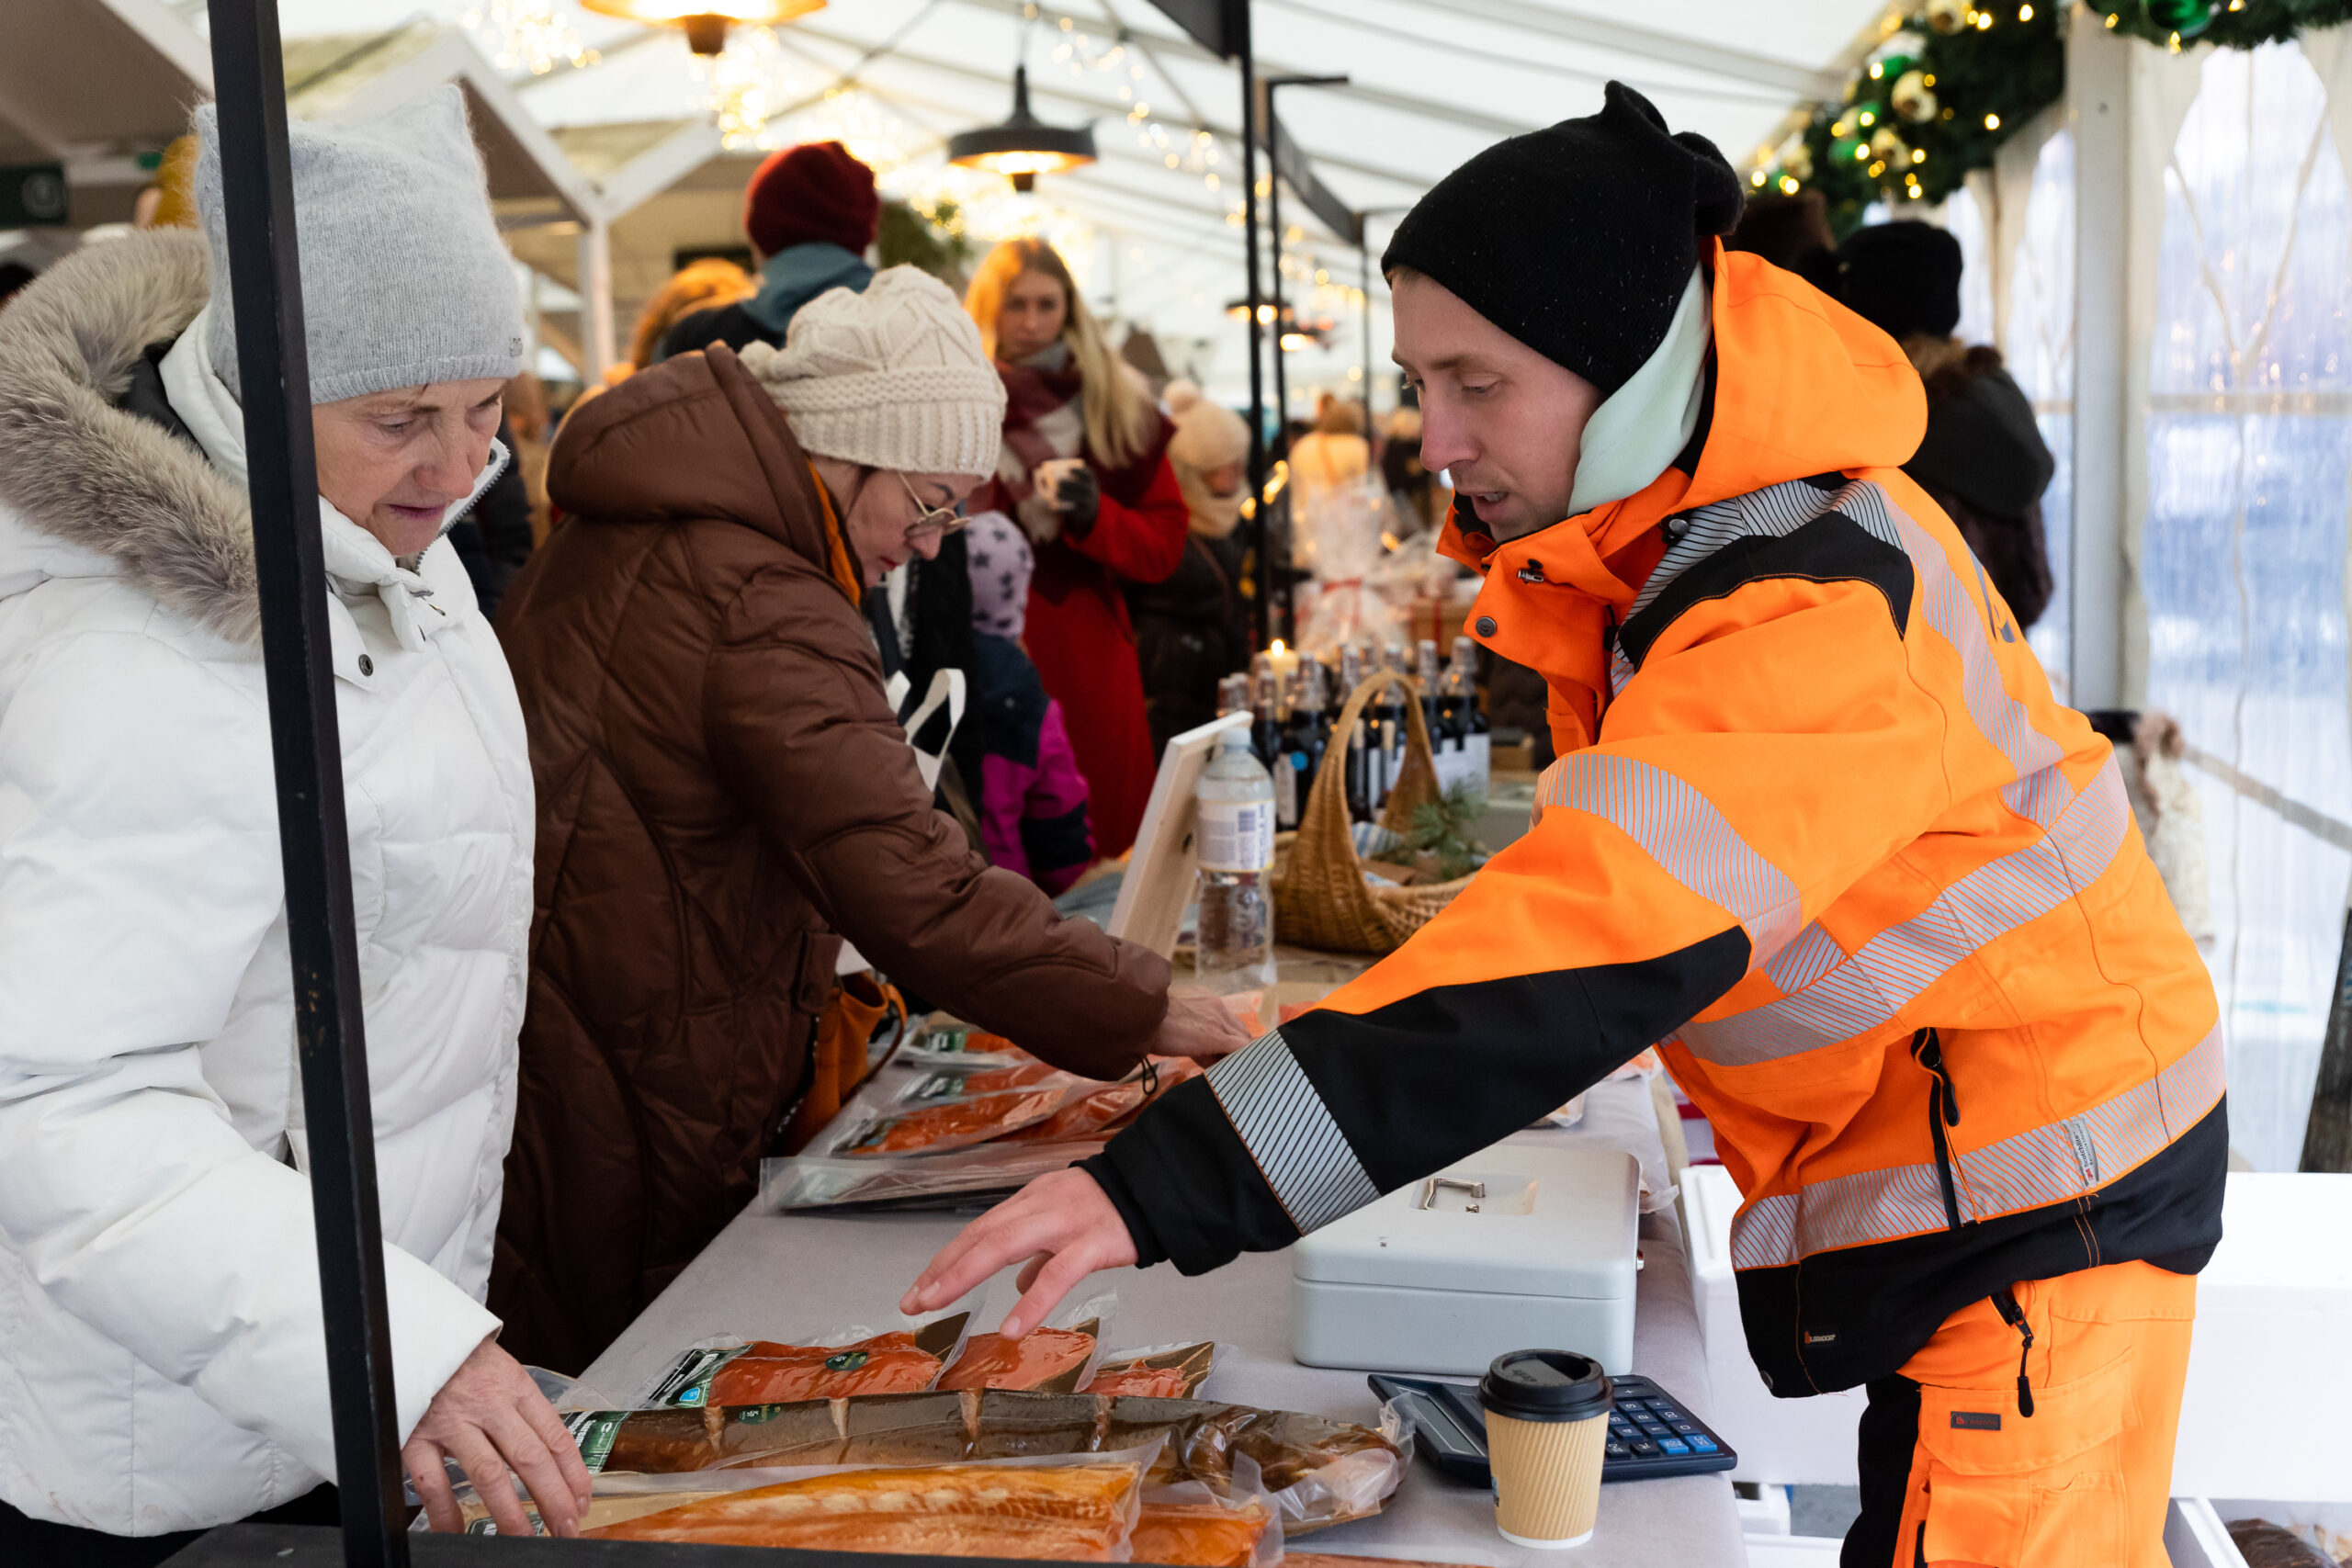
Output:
967,513,1093,894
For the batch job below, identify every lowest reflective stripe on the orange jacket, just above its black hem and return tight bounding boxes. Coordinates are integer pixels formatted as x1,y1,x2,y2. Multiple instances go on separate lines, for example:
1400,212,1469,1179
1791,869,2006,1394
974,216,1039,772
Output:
1731,1025,2222,1269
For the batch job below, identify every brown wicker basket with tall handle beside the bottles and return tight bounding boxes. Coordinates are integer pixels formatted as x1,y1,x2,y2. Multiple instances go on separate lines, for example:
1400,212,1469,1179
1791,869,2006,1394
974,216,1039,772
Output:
1275,670,1470,954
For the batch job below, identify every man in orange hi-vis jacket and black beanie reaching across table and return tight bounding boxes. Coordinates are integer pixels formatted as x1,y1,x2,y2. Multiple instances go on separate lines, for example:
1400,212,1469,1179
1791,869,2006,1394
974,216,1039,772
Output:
908,85,2227,1568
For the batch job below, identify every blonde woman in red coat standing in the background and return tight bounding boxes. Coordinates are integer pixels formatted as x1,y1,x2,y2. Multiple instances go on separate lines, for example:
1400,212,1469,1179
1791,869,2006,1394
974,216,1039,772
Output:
965,240,1188,856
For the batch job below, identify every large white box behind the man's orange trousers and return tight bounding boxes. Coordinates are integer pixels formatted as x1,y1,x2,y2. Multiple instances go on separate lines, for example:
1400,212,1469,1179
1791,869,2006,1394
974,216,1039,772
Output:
1681,1166,2352,1502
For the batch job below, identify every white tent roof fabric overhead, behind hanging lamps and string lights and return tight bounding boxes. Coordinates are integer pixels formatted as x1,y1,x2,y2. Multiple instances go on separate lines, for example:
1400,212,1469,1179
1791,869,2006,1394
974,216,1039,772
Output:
248,0,1882,402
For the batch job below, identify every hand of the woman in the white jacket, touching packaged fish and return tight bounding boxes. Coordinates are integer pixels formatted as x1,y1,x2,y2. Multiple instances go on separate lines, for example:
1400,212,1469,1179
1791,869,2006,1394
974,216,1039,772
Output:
400,1335,593,1535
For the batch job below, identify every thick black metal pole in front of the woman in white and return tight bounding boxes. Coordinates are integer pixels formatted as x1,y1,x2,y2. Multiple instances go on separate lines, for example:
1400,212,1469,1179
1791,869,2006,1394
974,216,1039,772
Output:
211,0,409,1568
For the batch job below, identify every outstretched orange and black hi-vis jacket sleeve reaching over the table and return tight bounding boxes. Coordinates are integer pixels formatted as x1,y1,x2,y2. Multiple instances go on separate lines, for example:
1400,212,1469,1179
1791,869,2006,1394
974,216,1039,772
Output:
1089,487,2046,1272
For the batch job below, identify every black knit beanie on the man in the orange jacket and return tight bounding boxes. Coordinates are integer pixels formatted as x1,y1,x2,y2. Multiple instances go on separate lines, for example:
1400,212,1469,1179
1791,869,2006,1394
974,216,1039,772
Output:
1381,83,1743,398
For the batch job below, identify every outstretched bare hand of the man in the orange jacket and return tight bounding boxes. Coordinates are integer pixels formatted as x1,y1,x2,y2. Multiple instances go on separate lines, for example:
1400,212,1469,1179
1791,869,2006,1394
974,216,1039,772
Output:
899,1166,1133,1340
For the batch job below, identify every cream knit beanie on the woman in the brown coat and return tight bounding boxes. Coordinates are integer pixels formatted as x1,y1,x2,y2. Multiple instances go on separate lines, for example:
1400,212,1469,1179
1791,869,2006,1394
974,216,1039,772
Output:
743,265,1004,478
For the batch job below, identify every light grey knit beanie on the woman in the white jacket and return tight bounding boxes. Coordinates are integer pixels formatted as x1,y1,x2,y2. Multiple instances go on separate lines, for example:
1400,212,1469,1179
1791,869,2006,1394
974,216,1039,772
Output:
195,87,522,402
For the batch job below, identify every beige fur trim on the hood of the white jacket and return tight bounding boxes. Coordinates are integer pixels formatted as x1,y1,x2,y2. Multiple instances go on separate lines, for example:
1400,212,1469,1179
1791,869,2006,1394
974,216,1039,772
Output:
0,231,261,644
